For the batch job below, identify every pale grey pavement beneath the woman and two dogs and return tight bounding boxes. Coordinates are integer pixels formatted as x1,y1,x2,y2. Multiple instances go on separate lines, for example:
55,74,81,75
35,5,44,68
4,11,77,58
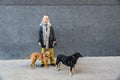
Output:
0,56,120,80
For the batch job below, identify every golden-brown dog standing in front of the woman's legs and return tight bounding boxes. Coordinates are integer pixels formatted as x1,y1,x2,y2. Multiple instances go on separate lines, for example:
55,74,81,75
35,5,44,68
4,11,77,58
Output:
26,51,51,68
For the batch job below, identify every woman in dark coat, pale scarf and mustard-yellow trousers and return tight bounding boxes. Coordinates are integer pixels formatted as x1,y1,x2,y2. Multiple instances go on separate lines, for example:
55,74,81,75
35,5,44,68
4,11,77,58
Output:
38,15,56,67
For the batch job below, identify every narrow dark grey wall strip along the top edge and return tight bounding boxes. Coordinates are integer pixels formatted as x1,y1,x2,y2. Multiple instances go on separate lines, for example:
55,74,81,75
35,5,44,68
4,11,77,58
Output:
0,0,120,6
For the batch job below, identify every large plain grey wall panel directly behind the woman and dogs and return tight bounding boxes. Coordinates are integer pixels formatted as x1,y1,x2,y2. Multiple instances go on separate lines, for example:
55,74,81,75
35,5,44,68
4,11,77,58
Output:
0,2,120,59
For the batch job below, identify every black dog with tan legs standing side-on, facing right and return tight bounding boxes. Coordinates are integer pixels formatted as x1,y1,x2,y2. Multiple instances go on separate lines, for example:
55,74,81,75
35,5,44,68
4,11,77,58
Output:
56,52,83,75
